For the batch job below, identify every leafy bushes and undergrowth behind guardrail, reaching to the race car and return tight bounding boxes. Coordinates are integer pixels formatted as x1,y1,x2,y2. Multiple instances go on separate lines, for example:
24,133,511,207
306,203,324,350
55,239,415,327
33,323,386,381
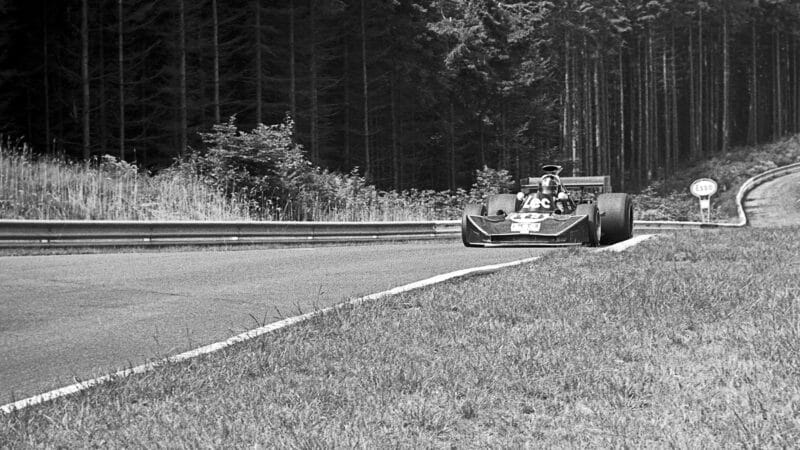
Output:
184,117,513,221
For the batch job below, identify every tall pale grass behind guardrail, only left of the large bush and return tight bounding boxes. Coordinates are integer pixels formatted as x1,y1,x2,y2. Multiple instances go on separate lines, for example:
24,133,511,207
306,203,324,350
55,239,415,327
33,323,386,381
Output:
0,146,251,220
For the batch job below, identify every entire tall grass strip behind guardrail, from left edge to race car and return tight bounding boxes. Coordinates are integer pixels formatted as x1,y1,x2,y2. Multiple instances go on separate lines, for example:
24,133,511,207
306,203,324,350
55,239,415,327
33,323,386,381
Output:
0,145,467,221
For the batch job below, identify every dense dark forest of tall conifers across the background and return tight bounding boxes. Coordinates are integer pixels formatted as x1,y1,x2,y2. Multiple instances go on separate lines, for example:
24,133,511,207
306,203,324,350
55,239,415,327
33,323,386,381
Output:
0,0,800,190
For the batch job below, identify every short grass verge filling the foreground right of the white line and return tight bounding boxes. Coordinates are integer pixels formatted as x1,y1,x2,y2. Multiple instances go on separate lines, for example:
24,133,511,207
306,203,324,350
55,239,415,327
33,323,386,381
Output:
0,227,800,448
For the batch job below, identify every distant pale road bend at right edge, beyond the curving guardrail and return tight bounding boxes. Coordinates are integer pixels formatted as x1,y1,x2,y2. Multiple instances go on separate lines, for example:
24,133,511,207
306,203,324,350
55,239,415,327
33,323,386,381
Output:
742,168,800,227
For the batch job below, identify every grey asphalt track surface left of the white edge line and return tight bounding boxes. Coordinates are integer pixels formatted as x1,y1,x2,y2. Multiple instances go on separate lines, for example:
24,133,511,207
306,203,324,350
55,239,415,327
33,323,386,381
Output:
0,241,552,404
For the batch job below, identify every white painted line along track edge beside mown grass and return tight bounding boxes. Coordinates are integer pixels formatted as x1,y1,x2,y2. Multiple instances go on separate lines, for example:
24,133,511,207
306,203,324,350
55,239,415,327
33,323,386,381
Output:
0,235,652,414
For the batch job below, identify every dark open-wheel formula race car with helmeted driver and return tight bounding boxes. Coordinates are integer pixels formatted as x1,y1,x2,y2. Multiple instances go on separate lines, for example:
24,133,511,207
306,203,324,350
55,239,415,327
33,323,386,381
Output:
461,165,633,247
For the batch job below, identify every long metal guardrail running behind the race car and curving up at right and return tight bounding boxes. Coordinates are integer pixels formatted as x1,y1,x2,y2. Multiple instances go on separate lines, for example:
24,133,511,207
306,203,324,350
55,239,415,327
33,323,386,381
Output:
0,163,800,248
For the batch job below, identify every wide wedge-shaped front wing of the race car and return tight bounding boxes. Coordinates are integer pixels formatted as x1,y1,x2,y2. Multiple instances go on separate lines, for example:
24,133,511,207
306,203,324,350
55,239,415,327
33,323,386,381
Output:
461,215,589,247
